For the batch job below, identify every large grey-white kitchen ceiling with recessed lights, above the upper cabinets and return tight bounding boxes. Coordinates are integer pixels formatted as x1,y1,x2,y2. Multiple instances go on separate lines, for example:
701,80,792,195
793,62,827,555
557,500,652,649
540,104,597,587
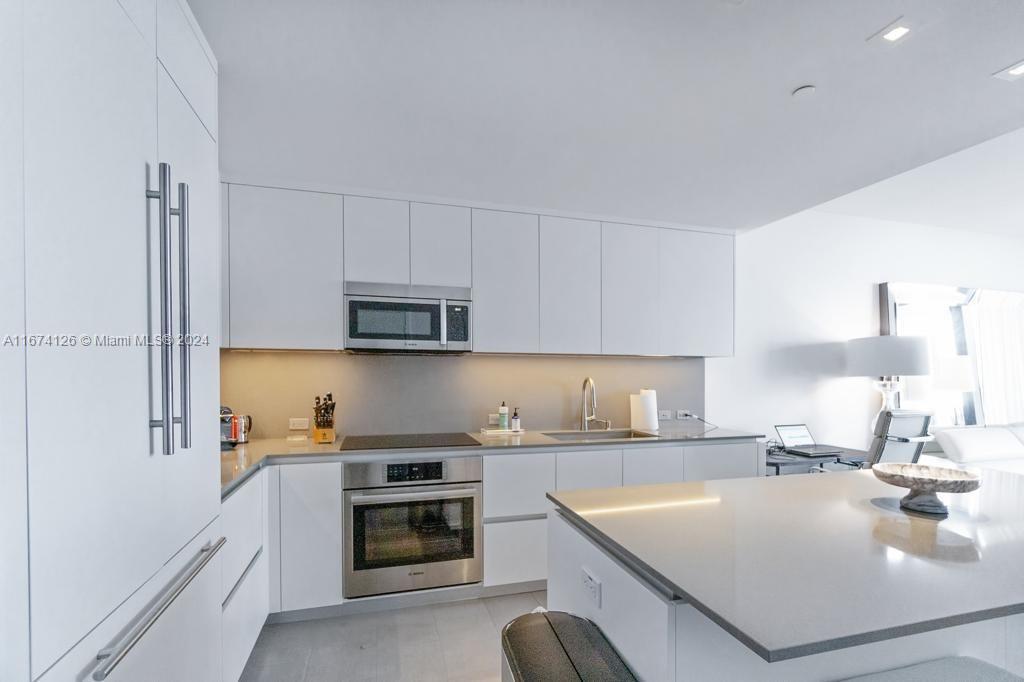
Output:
190,0,1024,229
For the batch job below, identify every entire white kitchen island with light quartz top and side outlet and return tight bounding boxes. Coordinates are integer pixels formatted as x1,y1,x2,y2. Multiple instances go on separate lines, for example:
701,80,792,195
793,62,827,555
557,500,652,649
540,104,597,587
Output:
548,470,1024,680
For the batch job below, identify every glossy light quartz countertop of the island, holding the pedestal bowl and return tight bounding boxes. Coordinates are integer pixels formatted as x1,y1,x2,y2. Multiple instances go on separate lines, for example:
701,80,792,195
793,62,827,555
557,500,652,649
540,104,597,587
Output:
548,470,1024,662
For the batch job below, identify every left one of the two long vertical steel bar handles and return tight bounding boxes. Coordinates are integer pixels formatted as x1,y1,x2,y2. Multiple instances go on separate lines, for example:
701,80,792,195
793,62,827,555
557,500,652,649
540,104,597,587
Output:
145,163,174,455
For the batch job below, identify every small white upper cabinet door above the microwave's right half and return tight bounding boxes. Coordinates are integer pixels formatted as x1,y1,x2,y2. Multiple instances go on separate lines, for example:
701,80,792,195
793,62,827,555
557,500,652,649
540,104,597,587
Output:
409,203,473,289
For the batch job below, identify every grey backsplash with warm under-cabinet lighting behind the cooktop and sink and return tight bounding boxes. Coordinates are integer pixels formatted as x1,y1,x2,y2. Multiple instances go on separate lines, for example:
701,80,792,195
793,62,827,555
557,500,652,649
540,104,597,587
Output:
220,350,705,438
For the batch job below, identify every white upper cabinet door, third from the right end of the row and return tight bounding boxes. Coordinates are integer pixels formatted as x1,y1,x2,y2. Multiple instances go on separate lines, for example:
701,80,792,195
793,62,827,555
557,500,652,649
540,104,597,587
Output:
540,216,601,355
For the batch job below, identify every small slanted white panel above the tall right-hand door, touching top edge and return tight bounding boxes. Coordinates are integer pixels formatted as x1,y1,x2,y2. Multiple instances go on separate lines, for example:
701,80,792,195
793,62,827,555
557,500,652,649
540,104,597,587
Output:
157,0,217,139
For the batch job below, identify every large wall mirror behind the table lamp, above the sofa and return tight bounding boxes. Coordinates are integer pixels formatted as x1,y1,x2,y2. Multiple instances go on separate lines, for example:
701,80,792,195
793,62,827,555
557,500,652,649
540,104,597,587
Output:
880,283,1024,426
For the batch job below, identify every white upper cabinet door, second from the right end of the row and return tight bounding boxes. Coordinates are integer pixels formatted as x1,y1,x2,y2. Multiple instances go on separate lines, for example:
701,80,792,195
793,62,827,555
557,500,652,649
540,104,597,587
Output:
601,222,662,355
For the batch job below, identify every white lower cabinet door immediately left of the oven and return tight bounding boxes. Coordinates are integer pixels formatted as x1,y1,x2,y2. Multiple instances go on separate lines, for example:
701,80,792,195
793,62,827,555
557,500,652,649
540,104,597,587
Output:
280,462,342,611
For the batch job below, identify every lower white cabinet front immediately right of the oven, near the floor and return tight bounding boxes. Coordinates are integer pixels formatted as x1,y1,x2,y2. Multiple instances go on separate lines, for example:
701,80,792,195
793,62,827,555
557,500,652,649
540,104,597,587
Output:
483,518,548,587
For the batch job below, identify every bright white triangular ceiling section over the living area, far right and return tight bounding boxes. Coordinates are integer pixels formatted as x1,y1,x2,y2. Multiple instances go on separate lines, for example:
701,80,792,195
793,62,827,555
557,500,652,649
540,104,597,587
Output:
818,126,1024,237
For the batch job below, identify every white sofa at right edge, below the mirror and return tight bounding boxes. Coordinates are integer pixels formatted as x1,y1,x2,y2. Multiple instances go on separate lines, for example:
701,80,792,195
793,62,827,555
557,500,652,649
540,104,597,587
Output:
920,424,1024,474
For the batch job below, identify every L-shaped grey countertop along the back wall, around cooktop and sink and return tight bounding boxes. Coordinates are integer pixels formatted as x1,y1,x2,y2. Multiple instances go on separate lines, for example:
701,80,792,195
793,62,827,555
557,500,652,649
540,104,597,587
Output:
220,424,764,497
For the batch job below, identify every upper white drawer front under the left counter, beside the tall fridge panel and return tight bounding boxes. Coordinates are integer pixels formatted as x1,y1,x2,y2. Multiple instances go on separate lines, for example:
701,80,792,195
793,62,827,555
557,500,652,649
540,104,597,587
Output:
220,471,266,600
